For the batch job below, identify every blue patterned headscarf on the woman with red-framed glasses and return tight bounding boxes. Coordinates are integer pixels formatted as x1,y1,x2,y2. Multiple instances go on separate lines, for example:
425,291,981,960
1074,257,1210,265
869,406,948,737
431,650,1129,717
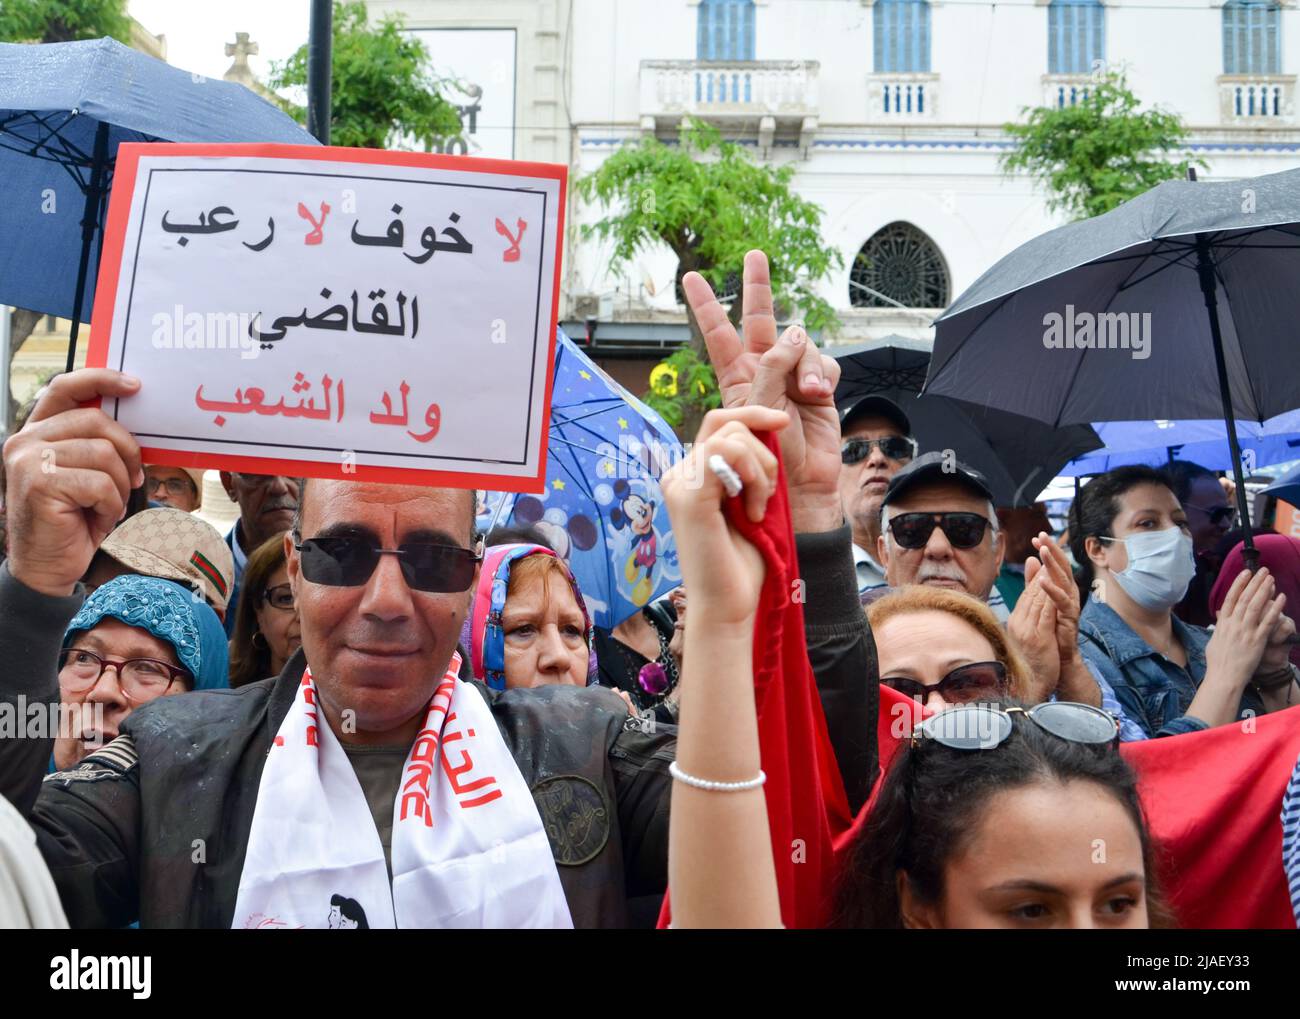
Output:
64,573,230,690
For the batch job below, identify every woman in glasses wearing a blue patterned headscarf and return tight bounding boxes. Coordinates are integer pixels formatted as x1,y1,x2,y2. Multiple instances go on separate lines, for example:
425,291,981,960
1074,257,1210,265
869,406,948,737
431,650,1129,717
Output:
53,574,229,771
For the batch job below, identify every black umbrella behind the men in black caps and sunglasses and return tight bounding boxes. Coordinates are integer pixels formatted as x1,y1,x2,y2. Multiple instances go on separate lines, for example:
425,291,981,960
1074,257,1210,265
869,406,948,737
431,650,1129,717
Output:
835,337,1101,507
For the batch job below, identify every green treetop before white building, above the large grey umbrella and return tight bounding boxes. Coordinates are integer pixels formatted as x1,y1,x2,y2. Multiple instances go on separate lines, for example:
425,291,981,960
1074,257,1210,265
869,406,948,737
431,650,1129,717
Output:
1001,70,1205,220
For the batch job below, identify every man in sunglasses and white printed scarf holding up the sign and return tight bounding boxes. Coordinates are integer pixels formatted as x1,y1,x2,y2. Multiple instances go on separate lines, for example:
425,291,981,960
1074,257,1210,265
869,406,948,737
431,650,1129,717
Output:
0,369,676,928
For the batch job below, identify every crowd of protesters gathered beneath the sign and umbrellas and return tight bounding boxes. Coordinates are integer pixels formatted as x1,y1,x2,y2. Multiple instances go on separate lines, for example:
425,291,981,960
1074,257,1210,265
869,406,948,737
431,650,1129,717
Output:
0,252,1300,928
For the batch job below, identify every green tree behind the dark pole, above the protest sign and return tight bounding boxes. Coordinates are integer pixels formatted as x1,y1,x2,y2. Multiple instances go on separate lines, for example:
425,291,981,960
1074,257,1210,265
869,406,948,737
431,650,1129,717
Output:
270,3,460,152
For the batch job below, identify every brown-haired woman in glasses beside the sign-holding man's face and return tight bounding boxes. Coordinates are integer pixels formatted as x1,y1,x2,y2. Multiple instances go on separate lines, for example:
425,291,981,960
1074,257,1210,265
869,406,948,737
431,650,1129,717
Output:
230,534,303,686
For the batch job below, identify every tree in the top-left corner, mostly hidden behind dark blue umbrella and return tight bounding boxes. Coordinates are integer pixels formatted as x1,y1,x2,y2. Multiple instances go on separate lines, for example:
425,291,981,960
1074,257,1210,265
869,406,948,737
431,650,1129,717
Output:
0,0,131,433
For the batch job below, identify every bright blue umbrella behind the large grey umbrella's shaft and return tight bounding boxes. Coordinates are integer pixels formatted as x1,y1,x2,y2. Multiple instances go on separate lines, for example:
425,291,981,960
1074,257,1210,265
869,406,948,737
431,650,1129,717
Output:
1061,411,1300,477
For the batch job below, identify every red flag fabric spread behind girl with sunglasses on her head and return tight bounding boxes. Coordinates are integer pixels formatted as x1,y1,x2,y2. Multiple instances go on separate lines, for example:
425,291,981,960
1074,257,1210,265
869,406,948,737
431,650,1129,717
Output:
863,686,1300,929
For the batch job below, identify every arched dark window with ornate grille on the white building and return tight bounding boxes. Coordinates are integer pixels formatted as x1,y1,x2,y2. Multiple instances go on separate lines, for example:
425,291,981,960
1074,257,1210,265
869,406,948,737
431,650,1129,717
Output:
849,221,950,308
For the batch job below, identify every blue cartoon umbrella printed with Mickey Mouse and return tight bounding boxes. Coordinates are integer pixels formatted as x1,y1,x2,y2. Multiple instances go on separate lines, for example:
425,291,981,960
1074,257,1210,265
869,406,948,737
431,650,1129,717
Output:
478,330,683,629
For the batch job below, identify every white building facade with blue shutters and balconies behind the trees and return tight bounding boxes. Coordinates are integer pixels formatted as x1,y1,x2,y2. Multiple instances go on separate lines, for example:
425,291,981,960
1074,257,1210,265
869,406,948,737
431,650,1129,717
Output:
371,0,1300,356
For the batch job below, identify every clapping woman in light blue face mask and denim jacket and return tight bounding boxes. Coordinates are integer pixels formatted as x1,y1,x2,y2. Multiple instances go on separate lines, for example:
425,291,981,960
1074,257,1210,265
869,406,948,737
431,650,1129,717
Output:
1070,467,1300,736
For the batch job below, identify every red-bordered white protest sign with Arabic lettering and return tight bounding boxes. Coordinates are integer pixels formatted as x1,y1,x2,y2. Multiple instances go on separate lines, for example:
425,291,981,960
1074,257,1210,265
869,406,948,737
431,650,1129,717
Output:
87,144,566,493
